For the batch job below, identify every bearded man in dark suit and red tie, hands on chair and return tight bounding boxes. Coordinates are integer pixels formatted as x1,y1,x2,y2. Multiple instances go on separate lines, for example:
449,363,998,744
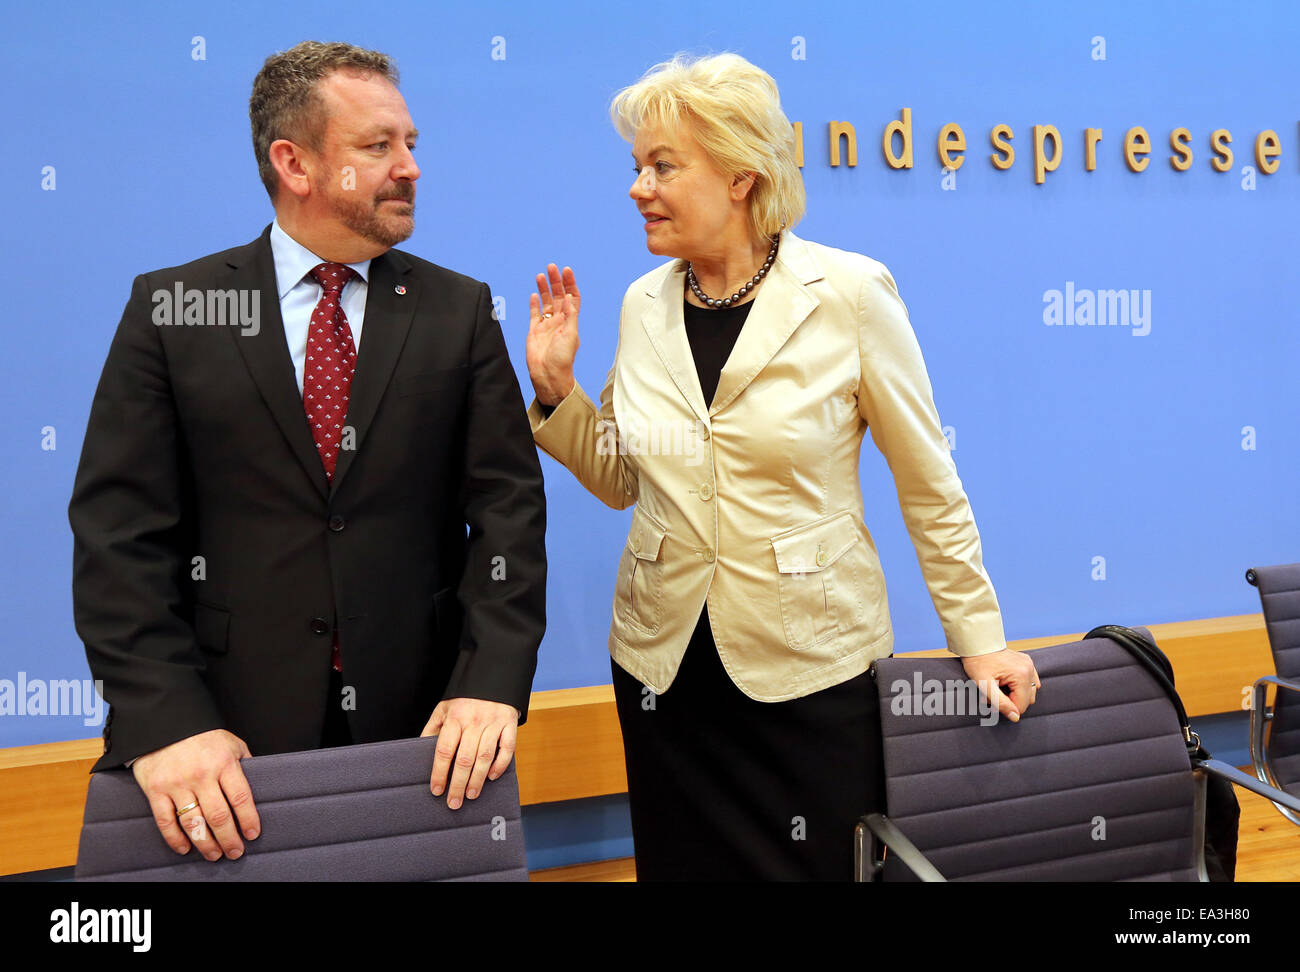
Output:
69,42,546,860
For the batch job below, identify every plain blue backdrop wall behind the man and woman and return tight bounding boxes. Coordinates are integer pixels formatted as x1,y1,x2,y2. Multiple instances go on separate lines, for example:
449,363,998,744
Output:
0,0,1300,746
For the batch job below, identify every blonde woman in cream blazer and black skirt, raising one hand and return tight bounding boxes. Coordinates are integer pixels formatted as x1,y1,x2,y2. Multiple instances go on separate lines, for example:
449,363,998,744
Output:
527,55,1037,880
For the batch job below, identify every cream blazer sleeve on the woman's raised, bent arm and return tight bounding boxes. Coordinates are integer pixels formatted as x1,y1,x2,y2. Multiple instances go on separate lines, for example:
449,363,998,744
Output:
528,298,638,509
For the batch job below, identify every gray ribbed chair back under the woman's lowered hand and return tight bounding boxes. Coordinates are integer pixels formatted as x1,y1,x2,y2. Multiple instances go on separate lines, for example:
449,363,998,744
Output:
875,628,1200,881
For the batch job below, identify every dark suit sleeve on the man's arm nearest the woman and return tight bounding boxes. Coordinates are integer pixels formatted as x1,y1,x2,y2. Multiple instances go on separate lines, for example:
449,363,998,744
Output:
443,285,546,724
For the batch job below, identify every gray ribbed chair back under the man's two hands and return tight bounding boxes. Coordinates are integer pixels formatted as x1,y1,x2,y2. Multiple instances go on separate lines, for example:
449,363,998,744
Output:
75,737,528,881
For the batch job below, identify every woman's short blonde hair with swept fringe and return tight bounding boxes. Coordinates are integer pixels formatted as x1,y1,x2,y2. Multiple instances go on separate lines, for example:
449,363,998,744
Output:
610,53,807,239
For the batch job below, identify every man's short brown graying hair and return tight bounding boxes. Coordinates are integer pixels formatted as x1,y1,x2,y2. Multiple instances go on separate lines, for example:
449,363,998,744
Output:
248,40,398,203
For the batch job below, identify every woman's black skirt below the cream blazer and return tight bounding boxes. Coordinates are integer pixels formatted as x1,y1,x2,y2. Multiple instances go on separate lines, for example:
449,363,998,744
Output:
611,607,884,881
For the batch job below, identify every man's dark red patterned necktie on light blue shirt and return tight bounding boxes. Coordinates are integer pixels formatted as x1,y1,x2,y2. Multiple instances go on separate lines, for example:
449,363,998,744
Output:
303,264,356,670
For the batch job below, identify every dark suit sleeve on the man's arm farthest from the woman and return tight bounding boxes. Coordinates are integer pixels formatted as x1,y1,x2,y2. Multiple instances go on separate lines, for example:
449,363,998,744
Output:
68,275,224,771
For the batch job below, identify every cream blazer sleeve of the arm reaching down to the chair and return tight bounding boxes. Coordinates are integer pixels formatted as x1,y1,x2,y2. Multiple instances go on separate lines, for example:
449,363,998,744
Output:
858,261,1006,655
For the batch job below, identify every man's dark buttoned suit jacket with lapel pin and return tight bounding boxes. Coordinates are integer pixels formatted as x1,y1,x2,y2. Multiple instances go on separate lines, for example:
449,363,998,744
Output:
69,226,546,771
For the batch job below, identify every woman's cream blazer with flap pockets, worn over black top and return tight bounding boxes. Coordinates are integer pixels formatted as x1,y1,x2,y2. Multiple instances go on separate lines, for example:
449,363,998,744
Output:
528,231,1006,702
